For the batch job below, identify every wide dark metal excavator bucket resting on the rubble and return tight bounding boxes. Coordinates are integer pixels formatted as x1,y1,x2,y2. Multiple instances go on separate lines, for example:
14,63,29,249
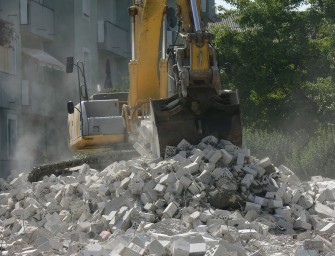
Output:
151,91,242,156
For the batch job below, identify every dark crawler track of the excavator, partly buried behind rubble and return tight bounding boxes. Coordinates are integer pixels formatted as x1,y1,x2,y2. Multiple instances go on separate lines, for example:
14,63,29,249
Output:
28,150,140,182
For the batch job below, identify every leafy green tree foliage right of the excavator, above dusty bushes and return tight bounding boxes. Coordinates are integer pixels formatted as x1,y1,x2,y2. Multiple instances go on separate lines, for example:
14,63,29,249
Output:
212,0,335,132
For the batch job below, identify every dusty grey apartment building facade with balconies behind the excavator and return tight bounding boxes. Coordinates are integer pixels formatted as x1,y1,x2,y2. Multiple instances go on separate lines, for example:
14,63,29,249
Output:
0,0,215,177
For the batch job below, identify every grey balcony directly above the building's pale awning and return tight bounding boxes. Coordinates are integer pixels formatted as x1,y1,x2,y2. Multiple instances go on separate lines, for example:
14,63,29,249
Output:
20,0,54,40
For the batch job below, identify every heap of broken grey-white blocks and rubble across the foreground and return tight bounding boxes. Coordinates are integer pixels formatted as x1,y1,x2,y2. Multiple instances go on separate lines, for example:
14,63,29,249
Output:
0,136,335,256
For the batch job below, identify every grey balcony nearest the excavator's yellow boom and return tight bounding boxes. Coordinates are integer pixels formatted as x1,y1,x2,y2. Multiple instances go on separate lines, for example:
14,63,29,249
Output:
98,20,131,59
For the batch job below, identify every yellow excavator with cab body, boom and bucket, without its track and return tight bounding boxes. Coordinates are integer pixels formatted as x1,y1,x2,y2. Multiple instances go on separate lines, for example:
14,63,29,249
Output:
67,0,242,156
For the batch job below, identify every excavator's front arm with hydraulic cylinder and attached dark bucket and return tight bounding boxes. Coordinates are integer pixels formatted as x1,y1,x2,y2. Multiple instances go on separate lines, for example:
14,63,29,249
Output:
151,0,242,155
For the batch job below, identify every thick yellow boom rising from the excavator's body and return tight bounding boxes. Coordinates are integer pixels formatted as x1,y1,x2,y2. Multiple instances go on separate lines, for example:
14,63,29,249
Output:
128,0,167,111
